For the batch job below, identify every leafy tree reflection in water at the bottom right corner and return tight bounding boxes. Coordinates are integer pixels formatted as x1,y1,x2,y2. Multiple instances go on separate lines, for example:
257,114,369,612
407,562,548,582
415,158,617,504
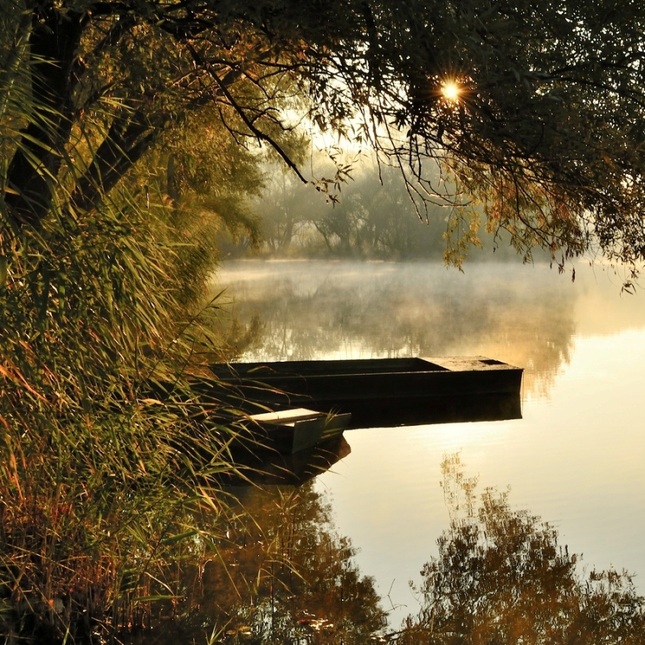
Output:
392,455,645,645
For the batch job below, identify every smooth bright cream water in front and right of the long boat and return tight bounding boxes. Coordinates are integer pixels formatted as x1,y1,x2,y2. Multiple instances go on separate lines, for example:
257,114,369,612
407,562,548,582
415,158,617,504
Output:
319,330,645,622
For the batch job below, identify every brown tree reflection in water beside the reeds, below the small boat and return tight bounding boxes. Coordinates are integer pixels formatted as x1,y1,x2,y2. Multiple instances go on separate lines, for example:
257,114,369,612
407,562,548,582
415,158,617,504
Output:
127,482,386,645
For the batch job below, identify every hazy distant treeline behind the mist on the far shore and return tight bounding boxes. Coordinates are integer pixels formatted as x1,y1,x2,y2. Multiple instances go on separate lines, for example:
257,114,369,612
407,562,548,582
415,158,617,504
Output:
220,158,548,262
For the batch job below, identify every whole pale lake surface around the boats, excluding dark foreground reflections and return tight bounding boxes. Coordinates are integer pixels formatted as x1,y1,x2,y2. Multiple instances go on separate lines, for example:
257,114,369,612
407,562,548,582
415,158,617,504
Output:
211,261,645,625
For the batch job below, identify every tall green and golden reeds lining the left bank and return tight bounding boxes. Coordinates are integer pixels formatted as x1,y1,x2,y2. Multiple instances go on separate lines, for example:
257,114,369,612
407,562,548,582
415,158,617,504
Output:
0,115,239,644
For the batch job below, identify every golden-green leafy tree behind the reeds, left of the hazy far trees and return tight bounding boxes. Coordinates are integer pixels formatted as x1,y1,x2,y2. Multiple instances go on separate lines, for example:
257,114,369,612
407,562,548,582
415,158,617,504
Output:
138,105,265,312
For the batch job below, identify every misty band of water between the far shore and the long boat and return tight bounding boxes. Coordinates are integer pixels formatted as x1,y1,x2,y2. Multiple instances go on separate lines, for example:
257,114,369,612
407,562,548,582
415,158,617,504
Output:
217,261,632,390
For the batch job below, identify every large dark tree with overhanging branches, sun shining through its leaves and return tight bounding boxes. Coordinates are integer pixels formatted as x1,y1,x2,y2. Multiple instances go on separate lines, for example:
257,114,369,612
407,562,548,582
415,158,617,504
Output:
6,0,645,268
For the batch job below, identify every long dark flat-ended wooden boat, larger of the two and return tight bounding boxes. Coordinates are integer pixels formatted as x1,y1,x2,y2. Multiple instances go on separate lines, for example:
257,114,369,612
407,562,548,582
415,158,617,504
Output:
206,356,523,428
